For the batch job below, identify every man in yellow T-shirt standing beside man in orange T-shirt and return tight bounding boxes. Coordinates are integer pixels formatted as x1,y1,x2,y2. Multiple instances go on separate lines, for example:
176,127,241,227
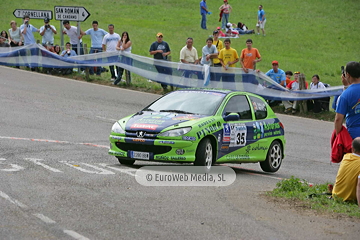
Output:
219,38,239,89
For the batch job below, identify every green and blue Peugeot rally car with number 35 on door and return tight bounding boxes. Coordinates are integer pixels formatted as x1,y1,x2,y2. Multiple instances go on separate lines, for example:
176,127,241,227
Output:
109,89,285,172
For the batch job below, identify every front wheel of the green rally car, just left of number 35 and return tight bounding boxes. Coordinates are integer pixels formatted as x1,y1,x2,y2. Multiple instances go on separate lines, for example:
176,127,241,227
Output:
194,138,213,171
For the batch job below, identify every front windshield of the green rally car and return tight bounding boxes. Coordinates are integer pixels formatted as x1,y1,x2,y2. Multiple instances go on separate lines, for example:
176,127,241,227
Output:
143,91,226,115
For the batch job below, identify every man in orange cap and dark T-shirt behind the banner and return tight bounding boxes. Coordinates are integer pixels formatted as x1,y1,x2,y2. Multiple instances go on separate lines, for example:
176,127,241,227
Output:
149,32,172,91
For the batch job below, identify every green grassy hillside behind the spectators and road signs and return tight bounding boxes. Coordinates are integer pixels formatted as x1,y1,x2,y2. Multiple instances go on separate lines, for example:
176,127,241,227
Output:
0,0,360,86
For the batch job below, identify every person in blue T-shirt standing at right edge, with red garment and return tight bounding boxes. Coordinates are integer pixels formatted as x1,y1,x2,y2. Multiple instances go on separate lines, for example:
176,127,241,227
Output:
334,62,360,139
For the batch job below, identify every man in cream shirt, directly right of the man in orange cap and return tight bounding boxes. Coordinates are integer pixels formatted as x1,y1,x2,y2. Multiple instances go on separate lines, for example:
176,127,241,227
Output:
180,37,203,79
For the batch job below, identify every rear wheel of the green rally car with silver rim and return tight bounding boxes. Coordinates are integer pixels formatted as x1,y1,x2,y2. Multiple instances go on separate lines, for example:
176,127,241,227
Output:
260,140,283,172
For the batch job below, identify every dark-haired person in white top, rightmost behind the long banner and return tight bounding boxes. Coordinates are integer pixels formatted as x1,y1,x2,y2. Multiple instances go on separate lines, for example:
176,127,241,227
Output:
307,74,330,113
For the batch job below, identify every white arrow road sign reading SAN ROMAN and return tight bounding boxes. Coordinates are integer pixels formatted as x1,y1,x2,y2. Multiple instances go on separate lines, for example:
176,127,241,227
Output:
54,6,90,22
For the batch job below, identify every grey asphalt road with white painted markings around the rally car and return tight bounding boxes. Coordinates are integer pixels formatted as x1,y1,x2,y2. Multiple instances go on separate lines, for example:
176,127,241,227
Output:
0,66,360,239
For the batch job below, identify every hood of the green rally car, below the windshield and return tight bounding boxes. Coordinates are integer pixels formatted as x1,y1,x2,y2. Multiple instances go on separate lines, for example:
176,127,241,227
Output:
125,111,208,133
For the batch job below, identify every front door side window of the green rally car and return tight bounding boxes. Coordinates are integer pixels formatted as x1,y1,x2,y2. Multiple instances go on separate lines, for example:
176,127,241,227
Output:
223,95,252,120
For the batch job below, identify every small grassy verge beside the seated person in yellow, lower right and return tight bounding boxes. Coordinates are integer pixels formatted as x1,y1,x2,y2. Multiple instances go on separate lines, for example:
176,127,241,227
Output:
267,176,360,219
